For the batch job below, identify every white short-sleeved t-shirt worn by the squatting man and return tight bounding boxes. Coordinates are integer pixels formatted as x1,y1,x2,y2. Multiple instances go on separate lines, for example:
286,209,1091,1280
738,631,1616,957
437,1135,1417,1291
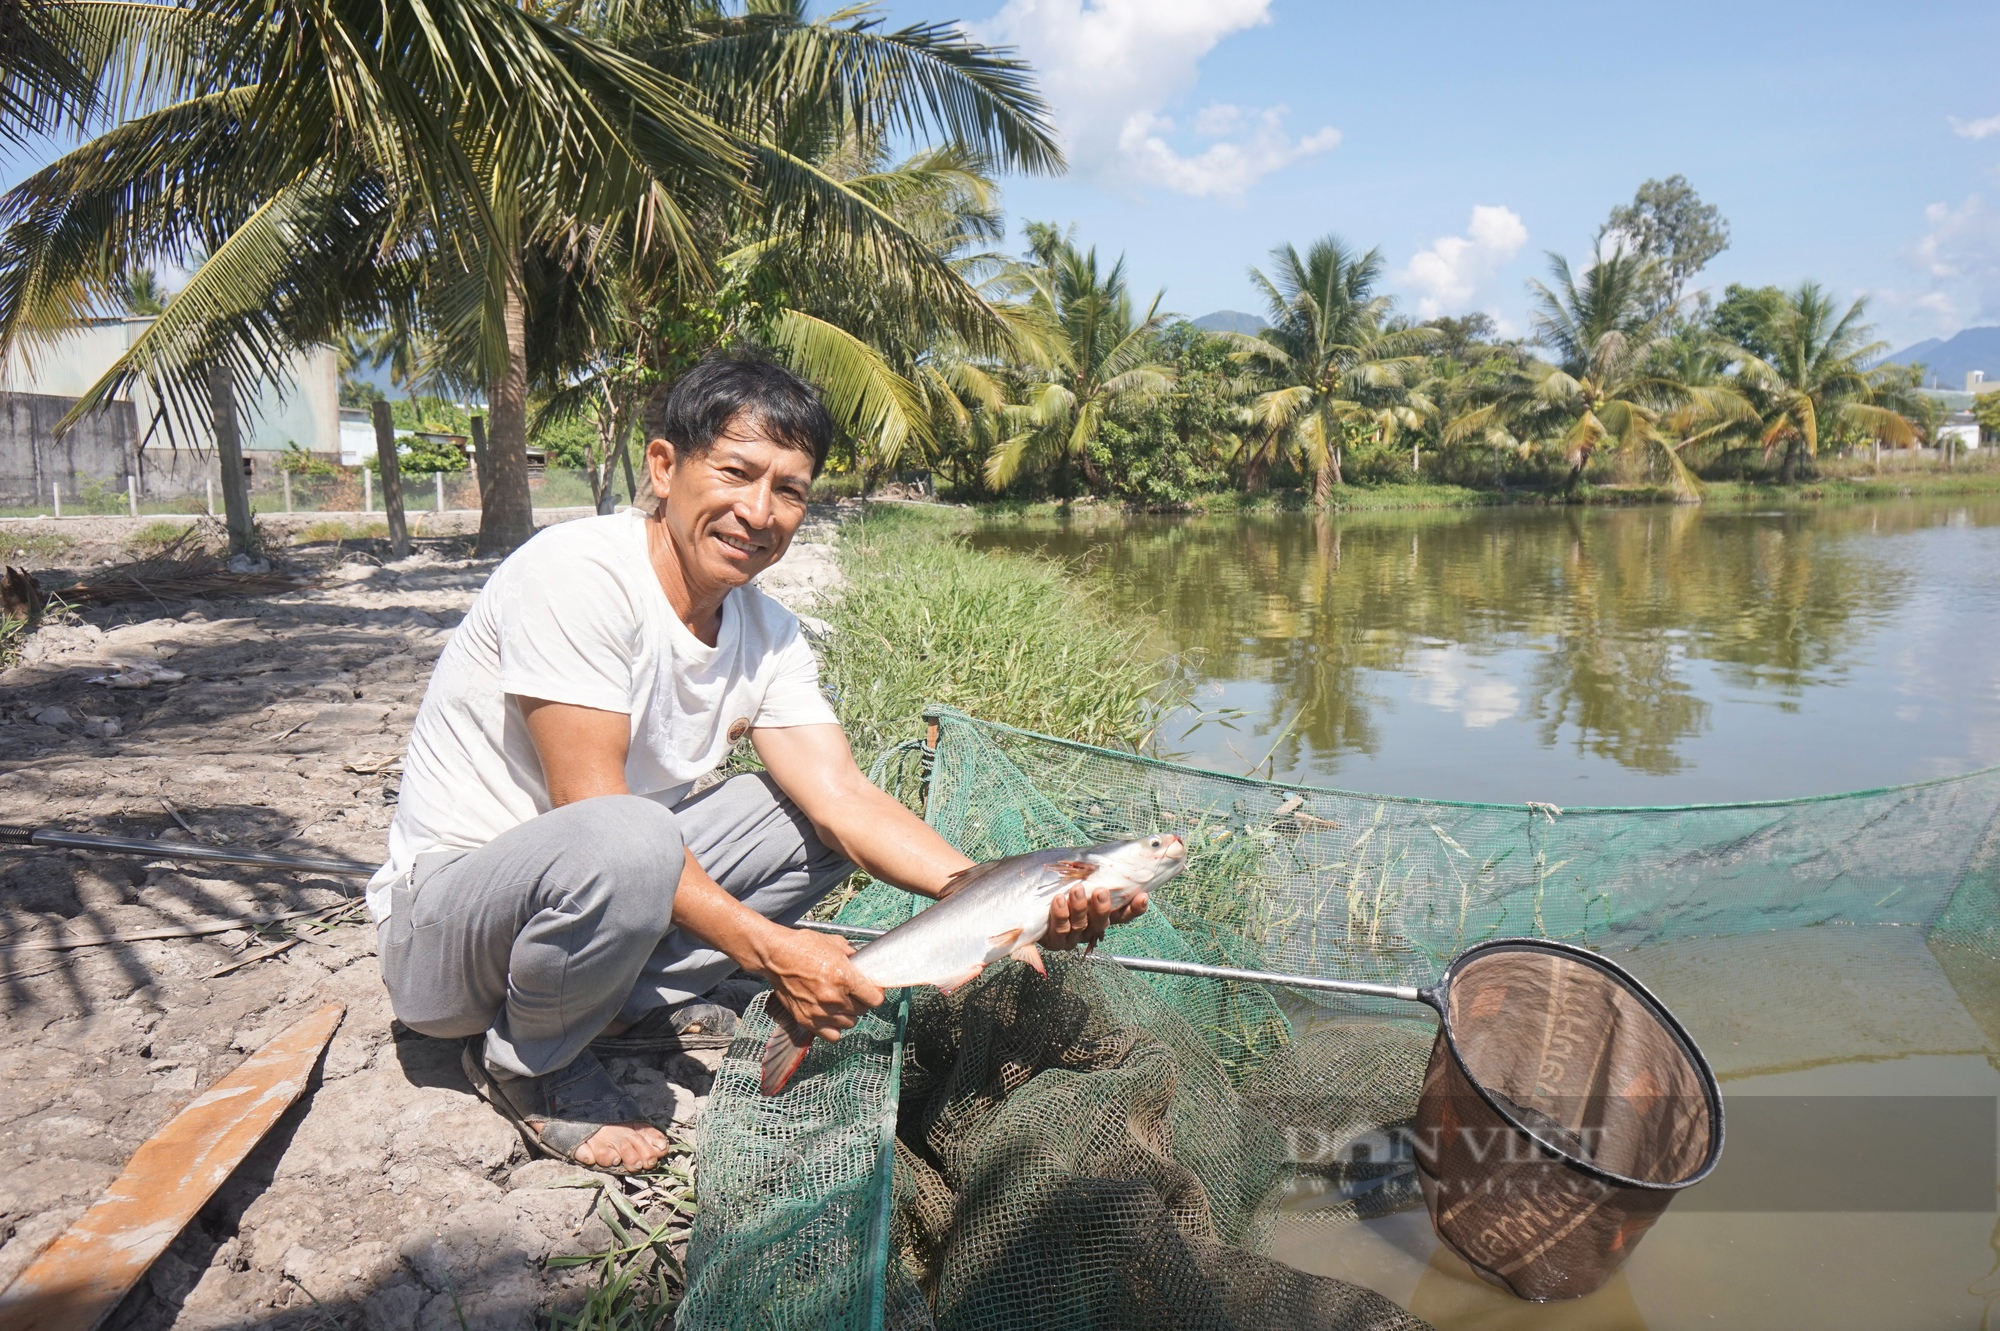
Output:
368,510,836,921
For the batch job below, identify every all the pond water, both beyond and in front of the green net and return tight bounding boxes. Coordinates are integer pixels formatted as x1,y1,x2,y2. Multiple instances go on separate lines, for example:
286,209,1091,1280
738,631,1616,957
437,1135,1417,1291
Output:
974,502,2000,1331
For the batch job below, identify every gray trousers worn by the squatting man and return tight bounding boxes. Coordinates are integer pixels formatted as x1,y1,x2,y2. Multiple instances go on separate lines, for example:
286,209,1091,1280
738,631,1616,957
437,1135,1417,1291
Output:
380,773,852,1077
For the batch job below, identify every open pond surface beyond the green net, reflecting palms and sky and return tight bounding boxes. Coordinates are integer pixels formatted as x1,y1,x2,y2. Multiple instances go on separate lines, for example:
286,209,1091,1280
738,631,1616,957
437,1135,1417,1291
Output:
972,502,2000,803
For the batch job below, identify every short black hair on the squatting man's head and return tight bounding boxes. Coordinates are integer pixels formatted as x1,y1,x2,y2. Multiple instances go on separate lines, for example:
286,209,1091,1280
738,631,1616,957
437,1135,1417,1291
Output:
642,354,834,476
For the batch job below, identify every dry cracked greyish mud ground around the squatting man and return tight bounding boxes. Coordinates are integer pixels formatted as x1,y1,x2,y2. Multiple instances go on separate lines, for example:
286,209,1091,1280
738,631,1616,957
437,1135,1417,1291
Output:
0,509,838,1331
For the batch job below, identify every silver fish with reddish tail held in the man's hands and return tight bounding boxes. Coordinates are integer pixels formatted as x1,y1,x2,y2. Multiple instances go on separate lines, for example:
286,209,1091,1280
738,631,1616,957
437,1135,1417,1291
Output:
760,835,1188,1095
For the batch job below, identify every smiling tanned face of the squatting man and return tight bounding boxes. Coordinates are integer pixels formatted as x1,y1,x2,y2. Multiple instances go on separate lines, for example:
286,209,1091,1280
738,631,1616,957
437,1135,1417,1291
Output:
646,403,812,594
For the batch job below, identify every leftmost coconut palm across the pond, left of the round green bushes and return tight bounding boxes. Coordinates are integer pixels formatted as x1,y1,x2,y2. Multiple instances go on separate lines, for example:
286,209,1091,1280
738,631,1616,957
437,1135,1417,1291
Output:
986,222,1174,490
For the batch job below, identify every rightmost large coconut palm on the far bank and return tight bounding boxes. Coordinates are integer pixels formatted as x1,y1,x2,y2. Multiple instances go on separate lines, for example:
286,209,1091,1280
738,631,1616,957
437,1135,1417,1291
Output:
1740,282,1916,484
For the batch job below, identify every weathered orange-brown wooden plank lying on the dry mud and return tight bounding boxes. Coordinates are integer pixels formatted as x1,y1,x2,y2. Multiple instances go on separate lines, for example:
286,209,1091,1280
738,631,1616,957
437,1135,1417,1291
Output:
0,1003,346,1331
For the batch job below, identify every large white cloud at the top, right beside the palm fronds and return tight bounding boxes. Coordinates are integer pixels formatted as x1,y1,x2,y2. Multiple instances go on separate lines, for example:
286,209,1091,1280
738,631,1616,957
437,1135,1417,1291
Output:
982,0,1340,198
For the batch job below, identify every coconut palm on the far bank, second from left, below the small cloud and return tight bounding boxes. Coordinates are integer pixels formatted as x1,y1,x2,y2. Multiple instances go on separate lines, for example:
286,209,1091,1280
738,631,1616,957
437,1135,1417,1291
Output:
1226,236,1438,506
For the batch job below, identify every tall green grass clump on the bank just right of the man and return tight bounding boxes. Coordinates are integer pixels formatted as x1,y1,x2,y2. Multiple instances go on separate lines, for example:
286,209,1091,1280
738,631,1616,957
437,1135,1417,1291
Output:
824,506,1184,761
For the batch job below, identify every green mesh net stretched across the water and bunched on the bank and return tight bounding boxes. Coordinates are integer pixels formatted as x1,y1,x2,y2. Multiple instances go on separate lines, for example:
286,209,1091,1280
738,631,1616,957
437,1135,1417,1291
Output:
676,711,2000,1331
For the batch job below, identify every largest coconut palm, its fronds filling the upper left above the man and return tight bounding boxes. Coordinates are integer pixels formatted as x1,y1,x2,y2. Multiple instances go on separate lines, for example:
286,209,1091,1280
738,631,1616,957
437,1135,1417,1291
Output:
0,0,1060,550
